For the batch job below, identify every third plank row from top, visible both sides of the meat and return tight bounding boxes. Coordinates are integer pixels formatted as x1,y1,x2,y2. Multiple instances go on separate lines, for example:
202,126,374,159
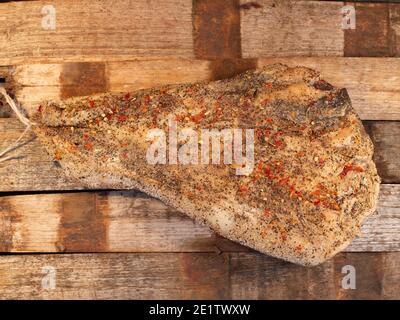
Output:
0,118,400,192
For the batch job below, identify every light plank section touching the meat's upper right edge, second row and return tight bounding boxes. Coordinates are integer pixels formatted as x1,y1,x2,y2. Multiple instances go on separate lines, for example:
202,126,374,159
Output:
258,57,400,120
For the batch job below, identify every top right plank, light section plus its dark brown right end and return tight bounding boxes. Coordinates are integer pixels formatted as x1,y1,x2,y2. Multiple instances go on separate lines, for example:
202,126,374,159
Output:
240,0,400,58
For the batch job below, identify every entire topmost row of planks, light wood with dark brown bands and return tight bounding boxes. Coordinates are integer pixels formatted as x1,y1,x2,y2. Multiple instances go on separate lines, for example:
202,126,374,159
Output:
0,0,400,65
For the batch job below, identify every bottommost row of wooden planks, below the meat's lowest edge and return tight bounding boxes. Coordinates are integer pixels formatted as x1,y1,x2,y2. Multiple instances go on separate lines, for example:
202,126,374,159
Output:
0,252,400,299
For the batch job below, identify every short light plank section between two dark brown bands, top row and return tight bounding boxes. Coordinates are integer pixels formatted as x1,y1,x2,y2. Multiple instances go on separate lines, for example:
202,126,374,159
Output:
240,0,344,58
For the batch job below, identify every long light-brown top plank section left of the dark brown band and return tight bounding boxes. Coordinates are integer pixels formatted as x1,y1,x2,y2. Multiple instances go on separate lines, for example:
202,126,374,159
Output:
0,0,194,65
